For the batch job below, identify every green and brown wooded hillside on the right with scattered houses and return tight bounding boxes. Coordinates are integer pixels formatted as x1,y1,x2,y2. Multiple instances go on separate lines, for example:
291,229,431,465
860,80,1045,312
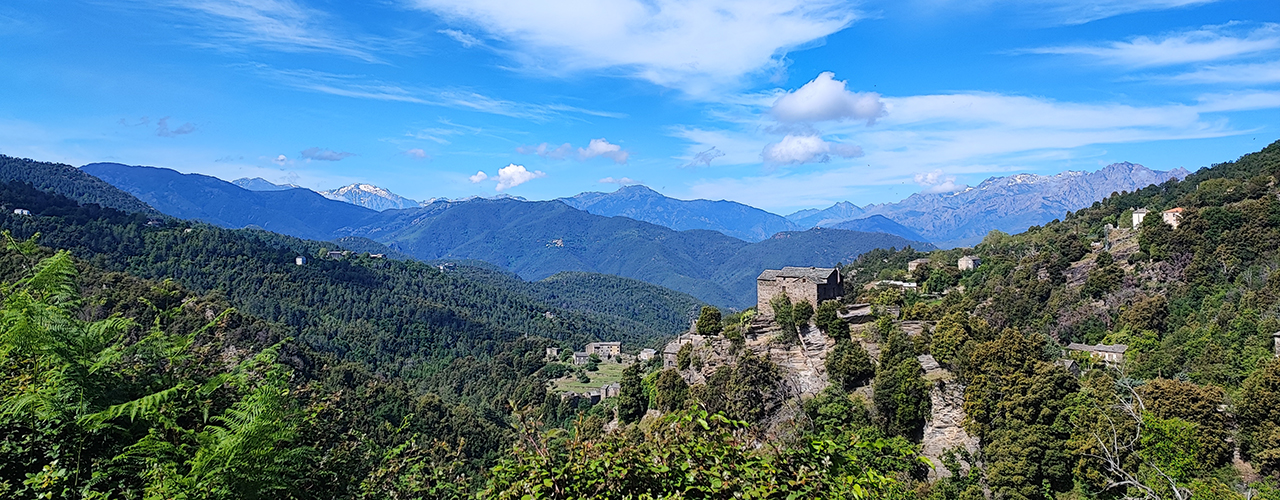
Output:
829,142,1280,499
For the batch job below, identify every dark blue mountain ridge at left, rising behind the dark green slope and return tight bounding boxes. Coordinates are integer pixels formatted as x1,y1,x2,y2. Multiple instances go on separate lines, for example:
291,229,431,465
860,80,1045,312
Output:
81,164,378,240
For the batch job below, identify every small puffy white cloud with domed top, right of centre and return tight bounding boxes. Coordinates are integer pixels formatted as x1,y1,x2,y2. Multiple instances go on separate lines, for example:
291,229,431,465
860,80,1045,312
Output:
769,72,884,125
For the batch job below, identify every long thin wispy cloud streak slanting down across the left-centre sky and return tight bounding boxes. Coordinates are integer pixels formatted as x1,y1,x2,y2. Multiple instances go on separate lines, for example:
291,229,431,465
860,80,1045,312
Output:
247,64,626,121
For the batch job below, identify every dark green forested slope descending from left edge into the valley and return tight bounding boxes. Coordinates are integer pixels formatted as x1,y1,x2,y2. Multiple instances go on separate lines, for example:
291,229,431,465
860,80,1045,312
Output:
0,177,691,405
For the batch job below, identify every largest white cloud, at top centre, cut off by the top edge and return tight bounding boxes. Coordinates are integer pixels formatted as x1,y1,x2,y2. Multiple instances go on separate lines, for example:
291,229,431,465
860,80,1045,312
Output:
411,0,859,96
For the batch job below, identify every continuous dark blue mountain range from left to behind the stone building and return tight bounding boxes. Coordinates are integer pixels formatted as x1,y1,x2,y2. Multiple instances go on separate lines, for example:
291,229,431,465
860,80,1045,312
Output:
82,164,933,308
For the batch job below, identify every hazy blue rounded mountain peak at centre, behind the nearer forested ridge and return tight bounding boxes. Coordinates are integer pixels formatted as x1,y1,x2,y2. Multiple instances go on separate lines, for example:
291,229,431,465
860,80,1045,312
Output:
559,185,801,242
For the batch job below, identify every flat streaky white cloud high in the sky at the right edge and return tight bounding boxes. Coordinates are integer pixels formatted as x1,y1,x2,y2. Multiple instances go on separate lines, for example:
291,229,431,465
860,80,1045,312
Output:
1019,23,1280,66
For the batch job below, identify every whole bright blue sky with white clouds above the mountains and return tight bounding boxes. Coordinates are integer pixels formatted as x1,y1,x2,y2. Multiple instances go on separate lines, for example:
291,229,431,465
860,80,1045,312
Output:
0,0,1280,214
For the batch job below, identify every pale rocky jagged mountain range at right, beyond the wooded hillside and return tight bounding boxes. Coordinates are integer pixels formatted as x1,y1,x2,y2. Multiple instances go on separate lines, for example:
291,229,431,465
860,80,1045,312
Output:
863,162,1190,248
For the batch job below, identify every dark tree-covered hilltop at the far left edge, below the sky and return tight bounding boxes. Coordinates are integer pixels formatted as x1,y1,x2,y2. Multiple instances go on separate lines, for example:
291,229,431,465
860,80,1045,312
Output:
0,155,159,214
